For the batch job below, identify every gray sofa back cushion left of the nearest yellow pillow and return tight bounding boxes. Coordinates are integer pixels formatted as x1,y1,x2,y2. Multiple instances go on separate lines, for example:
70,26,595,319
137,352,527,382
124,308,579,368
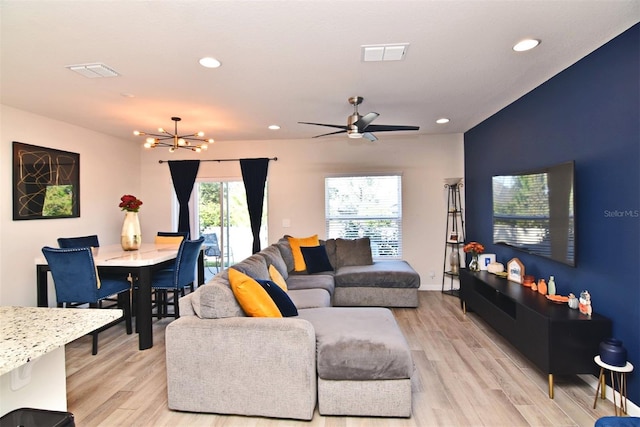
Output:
190,274,245,319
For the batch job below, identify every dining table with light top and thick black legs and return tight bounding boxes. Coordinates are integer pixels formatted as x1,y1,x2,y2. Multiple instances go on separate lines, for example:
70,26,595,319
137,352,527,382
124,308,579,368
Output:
35,243,204,350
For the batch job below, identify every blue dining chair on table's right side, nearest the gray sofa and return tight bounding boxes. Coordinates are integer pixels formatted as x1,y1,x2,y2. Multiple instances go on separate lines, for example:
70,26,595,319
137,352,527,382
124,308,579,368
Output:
151,237,204,319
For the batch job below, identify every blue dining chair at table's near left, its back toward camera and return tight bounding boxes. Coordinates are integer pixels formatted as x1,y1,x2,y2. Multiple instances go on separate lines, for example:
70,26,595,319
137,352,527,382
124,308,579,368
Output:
42,246,132,355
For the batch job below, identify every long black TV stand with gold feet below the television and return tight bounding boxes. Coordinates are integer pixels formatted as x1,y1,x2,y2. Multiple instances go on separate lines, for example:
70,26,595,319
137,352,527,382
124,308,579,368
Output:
460,269,611,399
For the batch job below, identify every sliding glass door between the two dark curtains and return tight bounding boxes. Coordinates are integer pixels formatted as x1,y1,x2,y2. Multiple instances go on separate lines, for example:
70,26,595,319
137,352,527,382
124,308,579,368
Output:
194,180,267,280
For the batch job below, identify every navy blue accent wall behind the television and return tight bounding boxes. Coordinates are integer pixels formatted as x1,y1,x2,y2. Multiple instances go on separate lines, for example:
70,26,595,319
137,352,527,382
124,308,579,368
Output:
464,24,640,406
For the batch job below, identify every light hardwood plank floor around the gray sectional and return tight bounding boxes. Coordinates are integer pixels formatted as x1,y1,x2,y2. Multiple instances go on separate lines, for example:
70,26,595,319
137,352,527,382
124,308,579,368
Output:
66,292,613,427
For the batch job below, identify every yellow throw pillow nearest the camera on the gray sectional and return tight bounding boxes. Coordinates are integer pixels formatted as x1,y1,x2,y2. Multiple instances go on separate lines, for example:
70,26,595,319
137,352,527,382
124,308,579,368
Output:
229,268,282,317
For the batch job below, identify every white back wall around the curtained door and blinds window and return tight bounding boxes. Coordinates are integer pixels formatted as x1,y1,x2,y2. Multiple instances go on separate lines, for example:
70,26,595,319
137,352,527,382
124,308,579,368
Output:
140,134,464,290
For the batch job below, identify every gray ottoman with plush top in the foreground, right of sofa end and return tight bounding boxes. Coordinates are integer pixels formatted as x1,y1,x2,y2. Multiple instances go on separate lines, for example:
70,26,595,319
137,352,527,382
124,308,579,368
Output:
299,307,414,417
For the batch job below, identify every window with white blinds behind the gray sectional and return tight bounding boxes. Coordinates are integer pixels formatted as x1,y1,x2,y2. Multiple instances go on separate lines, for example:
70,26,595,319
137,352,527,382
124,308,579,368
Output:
325,175,402,259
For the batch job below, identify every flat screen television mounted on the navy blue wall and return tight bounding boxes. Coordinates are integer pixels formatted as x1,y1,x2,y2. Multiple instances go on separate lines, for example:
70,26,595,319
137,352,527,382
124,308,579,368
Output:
492,162,576,266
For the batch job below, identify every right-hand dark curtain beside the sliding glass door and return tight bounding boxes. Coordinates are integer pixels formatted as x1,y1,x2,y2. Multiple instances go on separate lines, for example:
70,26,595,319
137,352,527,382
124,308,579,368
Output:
240,158,269,254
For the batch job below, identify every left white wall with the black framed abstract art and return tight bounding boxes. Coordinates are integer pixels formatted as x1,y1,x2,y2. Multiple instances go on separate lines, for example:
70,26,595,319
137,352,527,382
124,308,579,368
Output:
0,106,144,306
